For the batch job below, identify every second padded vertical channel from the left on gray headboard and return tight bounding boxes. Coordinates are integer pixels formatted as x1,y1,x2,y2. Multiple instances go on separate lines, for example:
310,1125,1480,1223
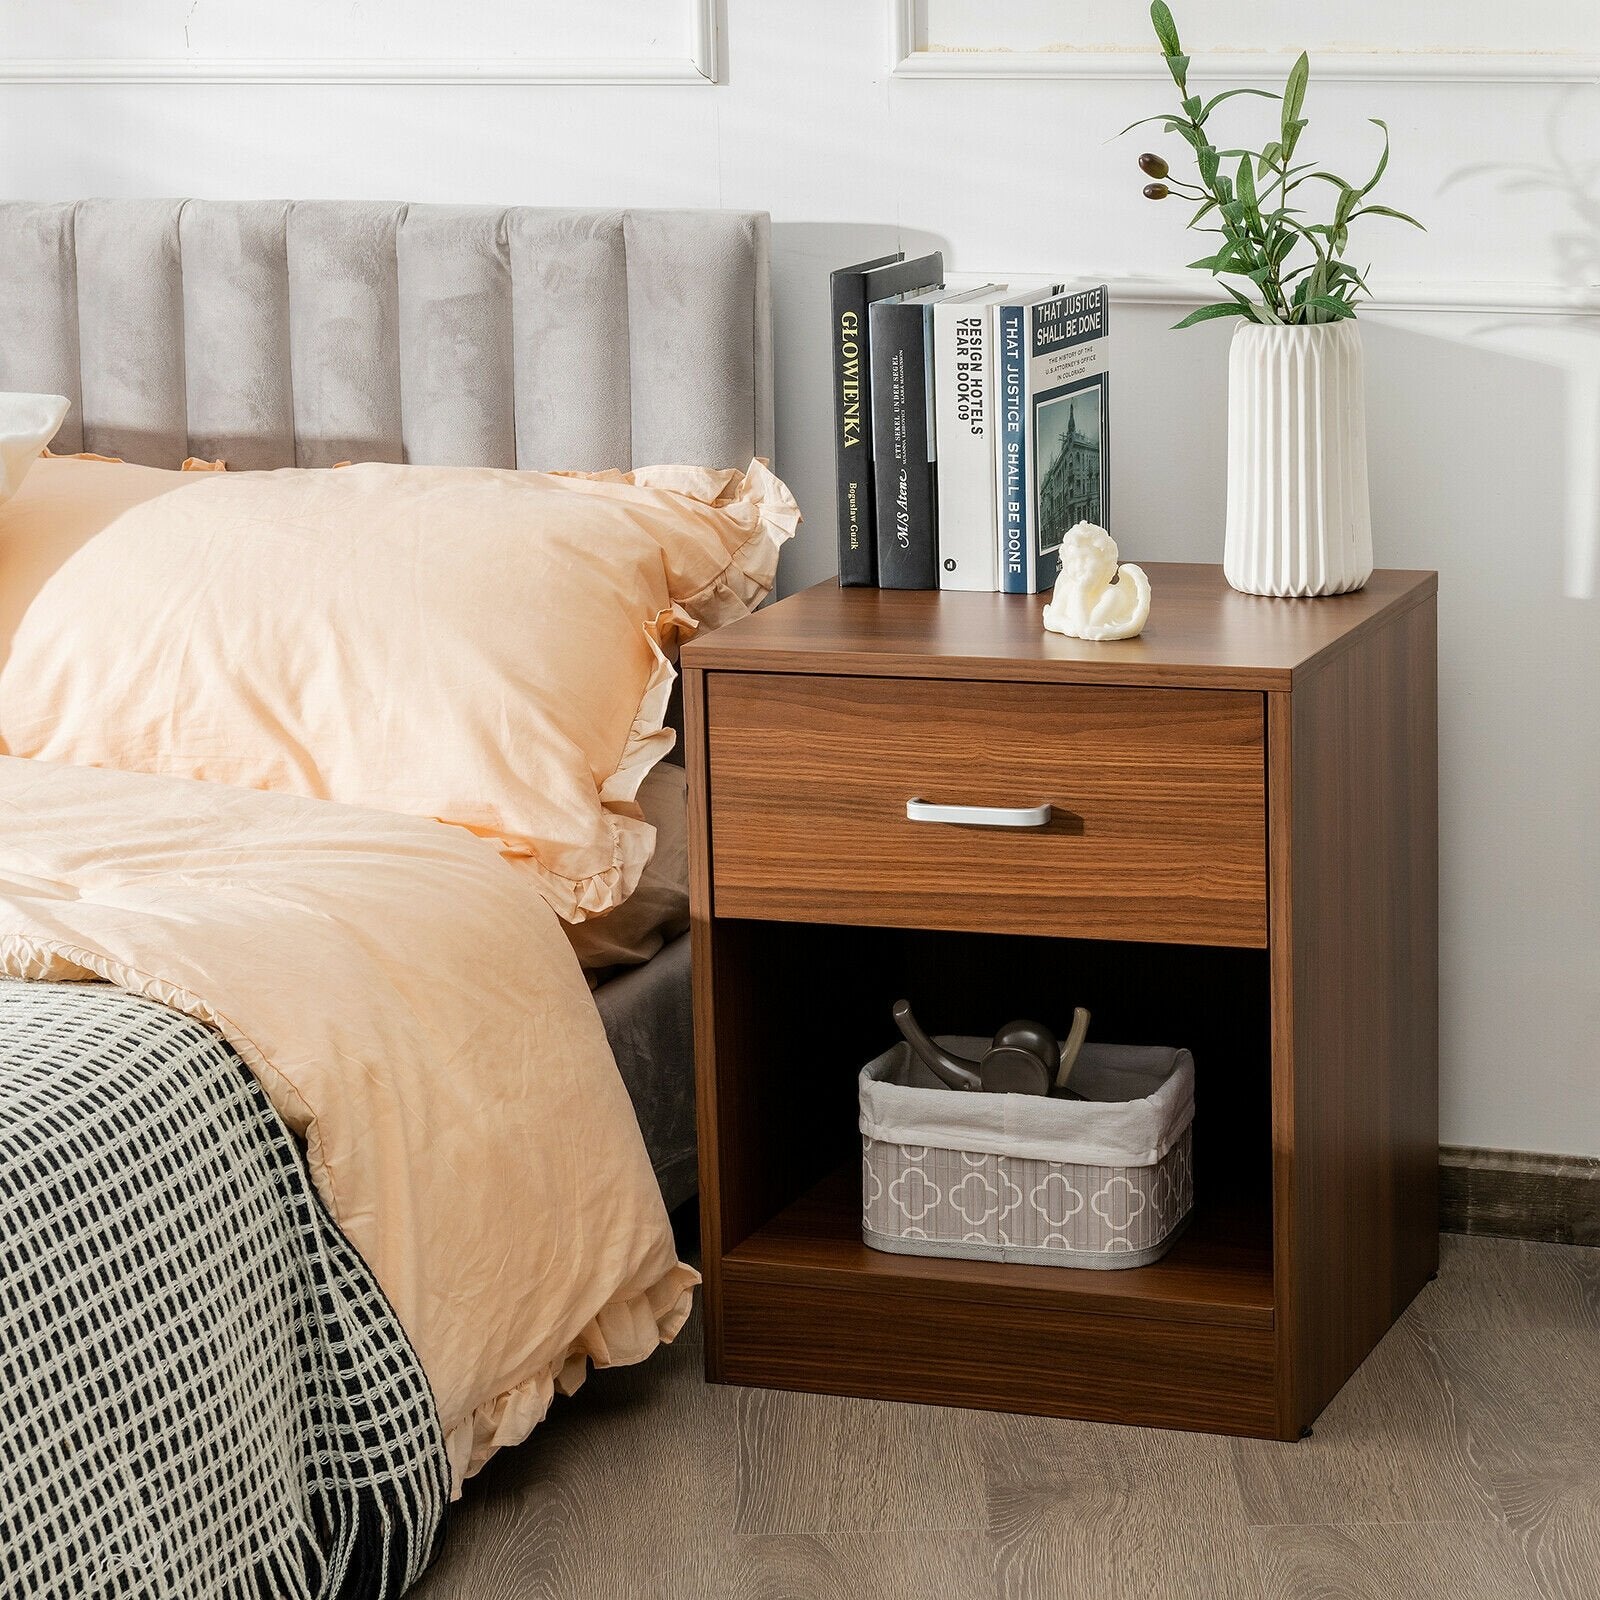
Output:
77,200,189,467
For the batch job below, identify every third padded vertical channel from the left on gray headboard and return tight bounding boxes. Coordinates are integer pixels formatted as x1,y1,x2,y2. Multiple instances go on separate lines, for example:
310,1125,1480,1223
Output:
178,200,294,470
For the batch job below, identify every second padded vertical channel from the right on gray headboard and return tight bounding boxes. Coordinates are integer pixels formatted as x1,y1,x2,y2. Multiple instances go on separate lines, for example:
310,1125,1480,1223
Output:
506,210,634,472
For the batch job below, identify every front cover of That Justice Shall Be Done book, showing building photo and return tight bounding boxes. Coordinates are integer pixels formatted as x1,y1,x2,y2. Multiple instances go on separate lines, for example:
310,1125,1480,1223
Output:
1024,283,1110,594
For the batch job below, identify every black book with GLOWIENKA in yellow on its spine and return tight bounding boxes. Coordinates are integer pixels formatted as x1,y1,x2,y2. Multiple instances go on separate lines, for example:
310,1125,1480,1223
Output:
829,251,944,586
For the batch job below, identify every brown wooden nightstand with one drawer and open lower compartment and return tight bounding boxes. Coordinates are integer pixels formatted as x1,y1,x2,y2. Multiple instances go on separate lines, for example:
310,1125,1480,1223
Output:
683,566,1438,1438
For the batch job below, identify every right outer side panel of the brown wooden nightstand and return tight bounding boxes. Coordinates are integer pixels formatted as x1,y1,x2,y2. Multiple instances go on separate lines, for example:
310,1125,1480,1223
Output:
1267,598,1438,1432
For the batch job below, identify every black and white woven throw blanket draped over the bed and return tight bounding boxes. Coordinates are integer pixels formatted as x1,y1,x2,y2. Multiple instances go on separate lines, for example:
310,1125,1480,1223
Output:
0,979,450,1600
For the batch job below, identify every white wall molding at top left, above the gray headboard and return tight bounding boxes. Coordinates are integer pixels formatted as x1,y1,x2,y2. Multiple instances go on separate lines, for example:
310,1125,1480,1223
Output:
0,0,722,88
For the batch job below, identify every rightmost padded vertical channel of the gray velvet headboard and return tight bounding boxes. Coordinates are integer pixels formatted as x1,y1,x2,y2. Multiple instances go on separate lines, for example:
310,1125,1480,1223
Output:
626,211,762,466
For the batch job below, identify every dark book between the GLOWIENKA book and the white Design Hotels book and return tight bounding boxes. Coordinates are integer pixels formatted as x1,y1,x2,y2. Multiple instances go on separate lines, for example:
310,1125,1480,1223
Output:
869,290,949,589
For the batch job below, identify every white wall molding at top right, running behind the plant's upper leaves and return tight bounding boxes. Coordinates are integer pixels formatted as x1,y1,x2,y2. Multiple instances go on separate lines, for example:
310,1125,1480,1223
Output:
888,0,1600,83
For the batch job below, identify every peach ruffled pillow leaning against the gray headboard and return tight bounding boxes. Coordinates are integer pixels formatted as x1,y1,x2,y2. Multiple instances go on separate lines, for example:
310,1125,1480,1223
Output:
0,459,800,922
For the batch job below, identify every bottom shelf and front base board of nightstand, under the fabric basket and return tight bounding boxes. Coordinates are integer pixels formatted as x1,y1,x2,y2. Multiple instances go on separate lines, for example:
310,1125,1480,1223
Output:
717,1168,1282,1437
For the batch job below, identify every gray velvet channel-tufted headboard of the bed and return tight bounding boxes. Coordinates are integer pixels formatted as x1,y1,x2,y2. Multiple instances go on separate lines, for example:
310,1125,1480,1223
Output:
0,200,773,470
